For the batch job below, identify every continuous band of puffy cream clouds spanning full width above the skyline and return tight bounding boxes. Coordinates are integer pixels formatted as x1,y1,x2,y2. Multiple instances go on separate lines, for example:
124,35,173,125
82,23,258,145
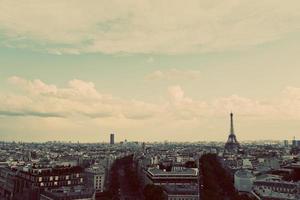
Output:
0,76,300,123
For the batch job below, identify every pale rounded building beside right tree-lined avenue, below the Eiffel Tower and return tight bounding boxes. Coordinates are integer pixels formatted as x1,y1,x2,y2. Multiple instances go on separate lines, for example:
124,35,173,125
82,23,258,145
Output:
234,170,255,192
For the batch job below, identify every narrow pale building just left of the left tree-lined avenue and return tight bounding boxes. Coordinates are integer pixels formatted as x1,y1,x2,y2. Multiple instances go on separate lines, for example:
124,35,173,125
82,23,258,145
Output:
85,166,106,192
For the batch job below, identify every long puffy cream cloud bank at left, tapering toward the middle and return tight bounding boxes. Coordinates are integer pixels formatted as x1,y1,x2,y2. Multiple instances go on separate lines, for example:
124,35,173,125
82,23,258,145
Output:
0,76,159,120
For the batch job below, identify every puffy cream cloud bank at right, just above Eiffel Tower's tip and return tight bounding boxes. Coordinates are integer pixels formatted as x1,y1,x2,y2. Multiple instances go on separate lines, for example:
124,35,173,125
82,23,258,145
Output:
167,85,300,120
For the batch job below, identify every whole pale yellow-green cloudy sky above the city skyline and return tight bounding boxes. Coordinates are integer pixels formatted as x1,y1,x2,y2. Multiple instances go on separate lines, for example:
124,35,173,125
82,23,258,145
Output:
0,0,300,142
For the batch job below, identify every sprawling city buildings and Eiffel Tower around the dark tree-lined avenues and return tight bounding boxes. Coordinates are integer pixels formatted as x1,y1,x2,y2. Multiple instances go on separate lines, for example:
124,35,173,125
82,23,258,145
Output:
0,113,300,200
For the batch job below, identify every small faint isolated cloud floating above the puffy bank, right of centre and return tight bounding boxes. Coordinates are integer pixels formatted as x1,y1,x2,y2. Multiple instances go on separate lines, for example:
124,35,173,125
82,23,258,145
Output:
146,69,200,80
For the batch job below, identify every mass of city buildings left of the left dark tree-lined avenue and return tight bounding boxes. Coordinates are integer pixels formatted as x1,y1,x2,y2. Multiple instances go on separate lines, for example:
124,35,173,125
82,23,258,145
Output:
0,142,135,200
